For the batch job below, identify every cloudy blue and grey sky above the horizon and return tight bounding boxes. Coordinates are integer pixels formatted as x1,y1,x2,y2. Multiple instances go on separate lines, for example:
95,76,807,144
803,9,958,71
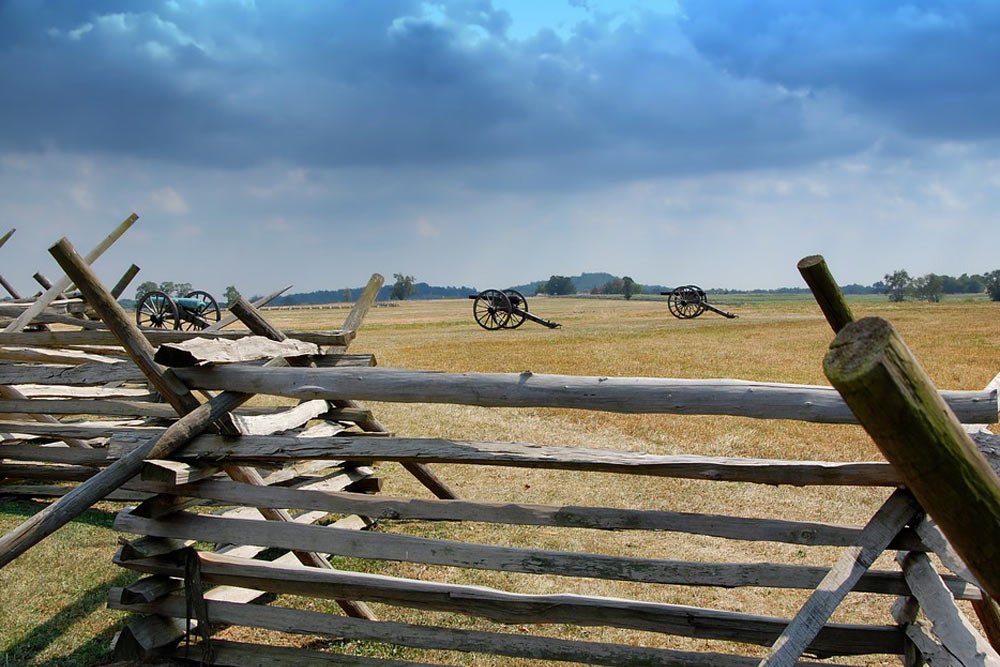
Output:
0,0,1000,295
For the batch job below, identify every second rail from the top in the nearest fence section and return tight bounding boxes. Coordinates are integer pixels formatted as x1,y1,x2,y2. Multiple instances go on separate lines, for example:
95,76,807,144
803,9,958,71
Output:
109,433,900,486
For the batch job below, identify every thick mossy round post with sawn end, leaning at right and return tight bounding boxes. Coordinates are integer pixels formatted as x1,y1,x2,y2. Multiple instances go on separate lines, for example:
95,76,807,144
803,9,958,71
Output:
823,317,1000,598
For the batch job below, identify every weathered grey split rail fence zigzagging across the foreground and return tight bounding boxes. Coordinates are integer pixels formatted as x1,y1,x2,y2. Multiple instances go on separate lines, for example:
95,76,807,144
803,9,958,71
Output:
0,226,1000,667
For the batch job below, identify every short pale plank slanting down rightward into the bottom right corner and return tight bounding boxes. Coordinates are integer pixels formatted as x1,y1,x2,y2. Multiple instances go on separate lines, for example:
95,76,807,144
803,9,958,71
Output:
897,553,1000,667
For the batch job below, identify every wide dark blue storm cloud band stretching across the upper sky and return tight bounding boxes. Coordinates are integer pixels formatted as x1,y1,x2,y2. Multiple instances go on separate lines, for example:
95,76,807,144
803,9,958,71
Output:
0,0,996,183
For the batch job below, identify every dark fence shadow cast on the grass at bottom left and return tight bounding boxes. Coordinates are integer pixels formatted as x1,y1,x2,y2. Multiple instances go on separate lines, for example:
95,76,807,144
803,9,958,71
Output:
0,572,138,667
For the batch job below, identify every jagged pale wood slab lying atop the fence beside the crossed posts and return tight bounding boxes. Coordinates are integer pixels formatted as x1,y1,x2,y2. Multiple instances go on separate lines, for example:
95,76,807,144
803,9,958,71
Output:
153,336,319,368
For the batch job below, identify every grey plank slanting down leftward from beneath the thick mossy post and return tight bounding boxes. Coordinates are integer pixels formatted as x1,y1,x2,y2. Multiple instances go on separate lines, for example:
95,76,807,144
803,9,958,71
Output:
759,489,920,667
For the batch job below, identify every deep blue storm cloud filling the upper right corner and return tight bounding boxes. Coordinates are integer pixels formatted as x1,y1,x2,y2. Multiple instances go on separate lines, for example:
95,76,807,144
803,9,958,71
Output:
681,0,1000,140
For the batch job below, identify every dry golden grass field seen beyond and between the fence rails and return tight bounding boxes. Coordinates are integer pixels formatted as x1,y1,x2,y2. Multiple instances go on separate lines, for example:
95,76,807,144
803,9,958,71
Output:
0,295,1000,667
